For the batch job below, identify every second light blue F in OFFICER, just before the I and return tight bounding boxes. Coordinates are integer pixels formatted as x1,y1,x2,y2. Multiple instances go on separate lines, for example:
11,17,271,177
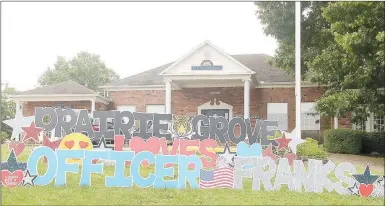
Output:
80,150,108,186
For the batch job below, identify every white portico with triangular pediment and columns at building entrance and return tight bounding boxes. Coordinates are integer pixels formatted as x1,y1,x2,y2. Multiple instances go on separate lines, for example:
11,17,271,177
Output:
159,41,255,119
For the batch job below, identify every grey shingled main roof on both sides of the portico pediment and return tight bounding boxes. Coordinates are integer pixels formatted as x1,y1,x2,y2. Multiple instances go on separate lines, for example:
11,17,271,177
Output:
103,54,294,87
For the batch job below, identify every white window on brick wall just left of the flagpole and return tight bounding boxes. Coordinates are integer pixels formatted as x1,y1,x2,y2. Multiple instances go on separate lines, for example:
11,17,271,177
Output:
267,103,288,131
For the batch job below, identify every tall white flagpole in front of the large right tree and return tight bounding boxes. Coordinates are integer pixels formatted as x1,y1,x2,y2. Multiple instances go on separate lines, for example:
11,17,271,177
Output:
295,1,301,139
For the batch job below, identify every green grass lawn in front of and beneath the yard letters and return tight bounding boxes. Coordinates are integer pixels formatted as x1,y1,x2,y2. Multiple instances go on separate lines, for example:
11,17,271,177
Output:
1,146,384,205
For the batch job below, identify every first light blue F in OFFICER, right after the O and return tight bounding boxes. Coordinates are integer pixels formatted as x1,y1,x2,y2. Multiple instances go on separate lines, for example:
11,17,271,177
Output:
55,149,84,186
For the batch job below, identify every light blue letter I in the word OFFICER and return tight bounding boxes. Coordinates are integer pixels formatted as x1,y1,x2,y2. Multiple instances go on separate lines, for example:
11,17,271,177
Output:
106,151,134,187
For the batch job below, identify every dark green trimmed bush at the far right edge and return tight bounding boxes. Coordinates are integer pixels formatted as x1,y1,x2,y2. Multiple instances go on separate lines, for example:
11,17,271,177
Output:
362,132,385,154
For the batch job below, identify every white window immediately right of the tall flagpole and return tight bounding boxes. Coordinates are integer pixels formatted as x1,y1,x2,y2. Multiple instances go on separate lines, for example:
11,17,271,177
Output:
301,102,321,131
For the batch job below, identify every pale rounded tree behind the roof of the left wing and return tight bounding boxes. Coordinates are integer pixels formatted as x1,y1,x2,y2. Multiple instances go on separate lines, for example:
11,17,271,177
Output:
38,52,119,91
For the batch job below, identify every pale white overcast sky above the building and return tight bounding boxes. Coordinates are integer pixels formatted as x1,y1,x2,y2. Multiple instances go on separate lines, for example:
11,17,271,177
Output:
1,2,277,91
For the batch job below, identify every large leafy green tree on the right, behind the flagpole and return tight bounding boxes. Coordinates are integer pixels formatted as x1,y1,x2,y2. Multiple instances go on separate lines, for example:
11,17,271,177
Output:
256,2,385,122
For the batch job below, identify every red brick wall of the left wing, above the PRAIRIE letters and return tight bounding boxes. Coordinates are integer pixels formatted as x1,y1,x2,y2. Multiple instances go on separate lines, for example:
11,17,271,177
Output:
23,101,108,116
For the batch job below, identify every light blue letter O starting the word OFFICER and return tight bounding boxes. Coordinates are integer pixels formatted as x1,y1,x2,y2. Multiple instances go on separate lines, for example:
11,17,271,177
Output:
27,146,57,185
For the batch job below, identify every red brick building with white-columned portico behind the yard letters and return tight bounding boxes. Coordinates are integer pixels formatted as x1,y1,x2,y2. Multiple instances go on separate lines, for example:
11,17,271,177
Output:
12,41,384,138
